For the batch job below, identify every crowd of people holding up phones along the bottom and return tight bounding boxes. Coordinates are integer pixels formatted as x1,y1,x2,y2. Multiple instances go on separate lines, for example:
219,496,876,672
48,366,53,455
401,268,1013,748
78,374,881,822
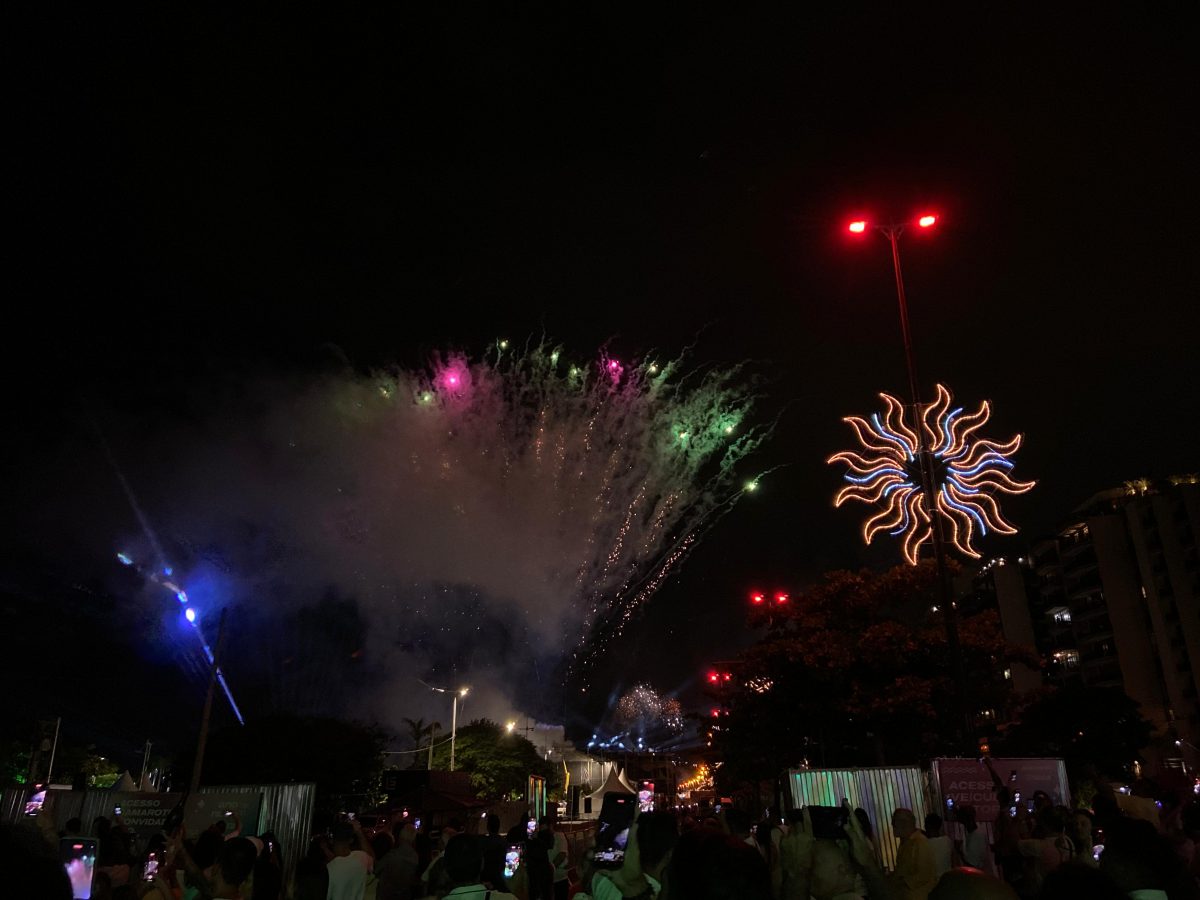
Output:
7,787,1200,900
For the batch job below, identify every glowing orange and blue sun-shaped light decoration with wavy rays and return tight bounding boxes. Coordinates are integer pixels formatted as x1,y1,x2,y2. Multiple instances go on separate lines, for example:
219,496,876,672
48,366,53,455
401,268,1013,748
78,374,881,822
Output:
828,384,1034,565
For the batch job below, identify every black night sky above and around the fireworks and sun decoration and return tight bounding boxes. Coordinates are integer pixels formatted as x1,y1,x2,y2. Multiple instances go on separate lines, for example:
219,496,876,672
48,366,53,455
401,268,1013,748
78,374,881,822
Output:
2,5,1200,753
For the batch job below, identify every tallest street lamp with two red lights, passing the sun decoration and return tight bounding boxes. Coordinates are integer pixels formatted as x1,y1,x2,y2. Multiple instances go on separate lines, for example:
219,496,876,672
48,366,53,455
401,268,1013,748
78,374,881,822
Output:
846,212,970,753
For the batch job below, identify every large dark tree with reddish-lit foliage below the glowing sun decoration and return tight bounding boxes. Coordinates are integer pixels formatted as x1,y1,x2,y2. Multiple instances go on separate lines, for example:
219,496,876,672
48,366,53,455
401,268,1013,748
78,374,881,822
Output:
710,563,1038,779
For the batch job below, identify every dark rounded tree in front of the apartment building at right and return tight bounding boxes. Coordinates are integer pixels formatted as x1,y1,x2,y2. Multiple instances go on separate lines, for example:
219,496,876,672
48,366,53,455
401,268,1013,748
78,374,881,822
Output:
996,685,1153,780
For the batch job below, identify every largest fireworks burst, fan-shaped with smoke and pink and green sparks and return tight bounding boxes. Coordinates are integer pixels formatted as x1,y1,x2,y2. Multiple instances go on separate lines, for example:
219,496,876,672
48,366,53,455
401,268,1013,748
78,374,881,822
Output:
274,342,766,691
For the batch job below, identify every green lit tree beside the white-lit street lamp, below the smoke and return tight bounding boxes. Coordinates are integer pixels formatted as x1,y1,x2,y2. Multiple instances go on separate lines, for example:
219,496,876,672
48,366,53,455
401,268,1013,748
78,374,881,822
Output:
433,719,557,799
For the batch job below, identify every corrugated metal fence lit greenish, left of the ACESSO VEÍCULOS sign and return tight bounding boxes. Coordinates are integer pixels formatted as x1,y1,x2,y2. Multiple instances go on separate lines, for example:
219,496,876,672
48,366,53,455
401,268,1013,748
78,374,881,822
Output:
787,767,932,869
